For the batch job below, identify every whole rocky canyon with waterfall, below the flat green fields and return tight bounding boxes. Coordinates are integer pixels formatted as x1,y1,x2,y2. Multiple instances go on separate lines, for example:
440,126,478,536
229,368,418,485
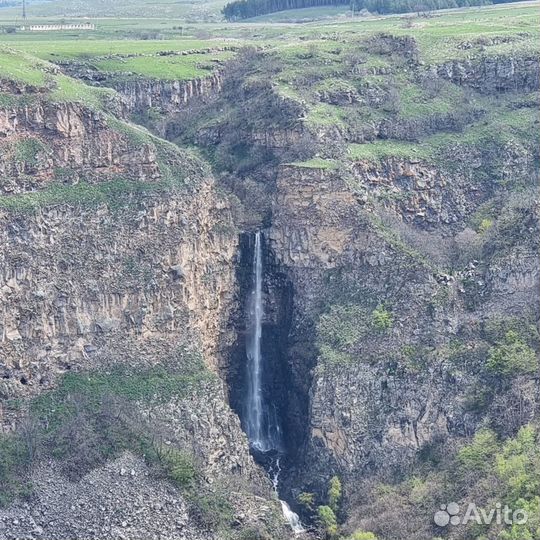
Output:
0,5,540,540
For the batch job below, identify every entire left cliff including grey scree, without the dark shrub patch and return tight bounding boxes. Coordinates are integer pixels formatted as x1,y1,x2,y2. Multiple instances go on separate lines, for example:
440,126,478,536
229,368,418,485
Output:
0,82,292,540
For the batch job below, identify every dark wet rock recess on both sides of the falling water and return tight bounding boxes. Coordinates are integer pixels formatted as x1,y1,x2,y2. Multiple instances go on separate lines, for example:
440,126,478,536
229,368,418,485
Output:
226,233,310,490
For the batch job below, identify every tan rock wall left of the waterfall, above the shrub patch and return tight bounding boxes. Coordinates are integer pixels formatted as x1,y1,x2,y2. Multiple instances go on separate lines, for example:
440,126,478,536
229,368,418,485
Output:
0,99,237,410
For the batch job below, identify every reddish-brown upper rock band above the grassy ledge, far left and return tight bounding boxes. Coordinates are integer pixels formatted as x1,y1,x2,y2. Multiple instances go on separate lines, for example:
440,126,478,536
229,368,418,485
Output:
0,101,154,193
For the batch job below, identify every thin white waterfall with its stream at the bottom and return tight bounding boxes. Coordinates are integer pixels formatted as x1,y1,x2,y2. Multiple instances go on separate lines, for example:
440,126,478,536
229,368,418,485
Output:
244,232,305,535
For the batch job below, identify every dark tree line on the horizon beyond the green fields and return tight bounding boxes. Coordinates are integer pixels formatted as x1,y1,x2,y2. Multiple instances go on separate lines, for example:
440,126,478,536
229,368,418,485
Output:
222,0,517,21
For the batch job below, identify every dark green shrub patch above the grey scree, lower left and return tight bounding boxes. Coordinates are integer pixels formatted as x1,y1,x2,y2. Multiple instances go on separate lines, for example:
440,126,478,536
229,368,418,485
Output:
0,352,214,505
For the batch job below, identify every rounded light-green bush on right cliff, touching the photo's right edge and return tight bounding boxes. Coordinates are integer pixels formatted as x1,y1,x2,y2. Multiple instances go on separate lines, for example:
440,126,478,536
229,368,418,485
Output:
486,330,538,376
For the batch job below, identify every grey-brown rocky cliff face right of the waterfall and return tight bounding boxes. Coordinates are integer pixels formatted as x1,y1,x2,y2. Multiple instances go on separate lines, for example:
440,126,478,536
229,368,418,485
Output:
269,156,540,502
